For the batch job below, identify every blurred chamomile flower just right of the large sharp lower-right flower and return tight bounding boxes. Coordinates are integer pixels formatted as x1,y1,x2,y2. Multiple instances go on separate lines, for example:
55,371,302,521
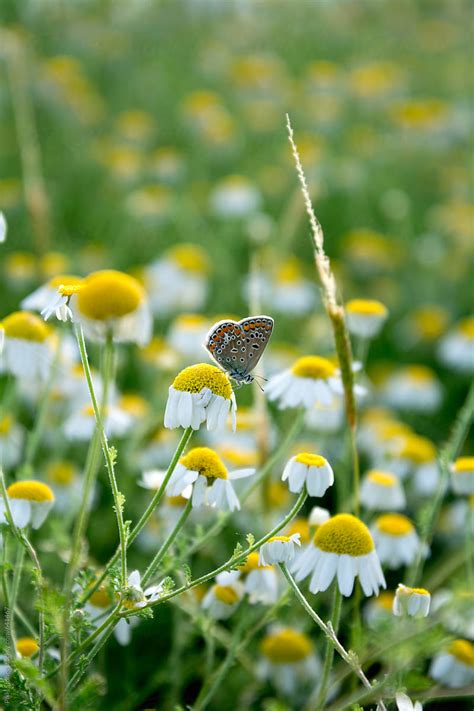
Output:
372,513,421,570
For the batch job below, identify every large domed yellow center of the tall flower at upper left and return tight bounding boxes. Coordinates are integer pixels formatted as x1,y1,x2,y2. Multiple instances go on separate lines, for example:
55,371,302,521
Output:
77,269,144,321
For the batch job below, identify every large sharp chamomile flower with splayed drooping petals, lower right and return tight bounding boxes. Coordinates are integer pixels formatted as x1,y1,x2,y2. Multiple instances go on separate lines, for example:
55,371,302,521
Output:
295,514,385,597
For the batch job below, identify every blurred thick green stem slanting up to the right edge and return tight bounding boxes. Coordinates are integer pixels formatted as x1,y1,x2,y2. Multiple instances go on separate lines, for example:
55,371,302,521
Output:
407,383,474,587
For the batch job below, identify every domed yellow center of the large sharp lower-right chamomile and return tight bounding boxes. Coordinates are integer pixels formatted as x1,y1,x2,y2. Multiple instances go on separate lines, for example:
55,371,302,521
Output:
313,514,374,557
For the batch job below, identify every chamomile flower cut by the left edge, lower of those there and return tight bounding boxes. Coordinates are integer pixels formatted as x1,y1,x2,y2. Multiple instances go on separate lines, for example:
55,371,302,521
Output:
0,480,54,528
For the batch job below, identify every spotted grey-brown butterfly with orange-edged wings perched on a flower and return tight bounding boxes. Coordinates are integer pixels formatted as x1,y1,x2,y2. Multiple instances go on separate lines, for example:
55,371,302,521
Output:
204,316,274,384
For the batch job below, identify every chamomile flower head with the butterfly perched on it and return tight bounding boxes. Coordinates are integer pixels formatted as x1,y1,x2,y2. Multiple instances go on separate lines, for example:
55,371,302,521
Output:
164,363,237,432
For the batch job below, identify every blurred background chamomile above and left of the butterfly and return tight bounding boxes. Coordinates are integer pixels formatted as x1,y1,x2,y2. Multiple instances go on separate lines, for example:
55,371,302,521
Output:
145,244,209,316
